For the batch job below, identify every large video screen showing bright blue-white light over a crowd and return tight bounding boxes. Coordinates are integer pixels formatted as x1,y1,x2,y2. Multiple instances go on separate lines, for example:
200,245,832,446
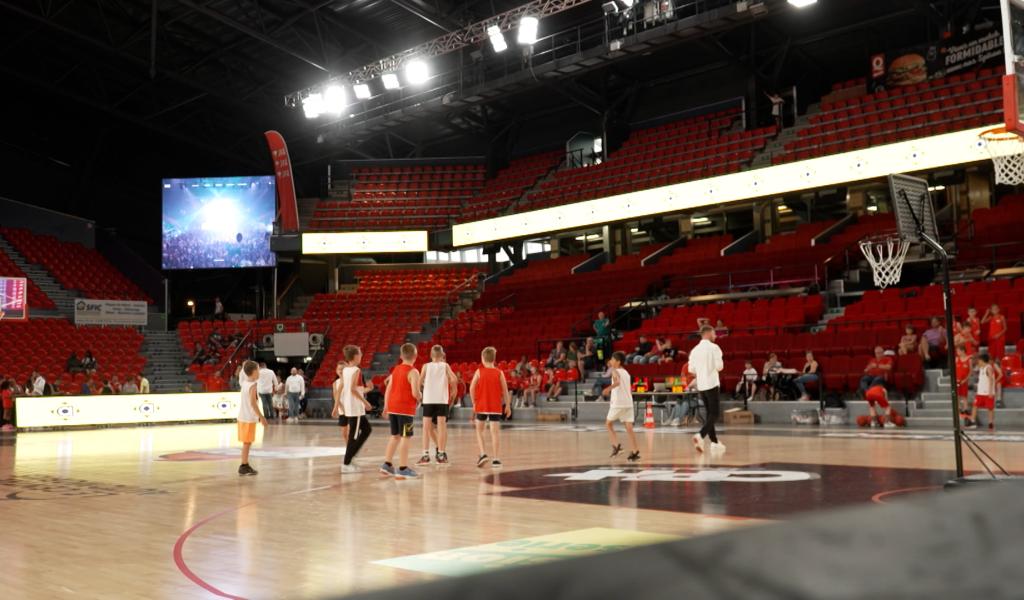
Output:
162,175,276,269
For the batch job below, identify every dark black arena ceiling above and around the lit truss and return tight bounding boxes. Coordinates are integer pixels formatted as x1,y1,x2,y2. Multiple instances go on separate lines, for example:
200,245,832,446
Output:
0,0,997,250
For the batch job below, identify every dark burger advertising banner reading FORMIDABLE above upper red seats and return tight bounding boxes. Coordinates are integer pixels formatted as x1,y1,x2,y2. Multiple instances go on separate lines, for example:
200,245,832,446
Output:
869,31,1002,90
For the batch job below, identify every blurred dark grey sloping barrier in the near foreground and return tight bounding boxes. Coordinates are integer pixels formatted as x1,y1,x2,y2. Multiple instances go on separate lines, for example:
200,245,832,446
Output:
348,482,1024,600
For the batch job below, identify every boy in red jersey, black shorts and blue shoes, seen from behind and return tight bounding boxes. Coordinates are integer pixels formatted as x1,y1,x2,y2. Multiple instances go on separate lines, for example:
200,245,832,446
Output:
381,344,422,479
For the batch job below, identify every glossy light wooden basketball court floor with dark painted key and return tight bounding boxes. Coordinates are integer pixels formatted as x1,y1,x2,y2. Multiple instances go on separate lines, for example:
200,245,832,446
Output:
0,423,1024,598
